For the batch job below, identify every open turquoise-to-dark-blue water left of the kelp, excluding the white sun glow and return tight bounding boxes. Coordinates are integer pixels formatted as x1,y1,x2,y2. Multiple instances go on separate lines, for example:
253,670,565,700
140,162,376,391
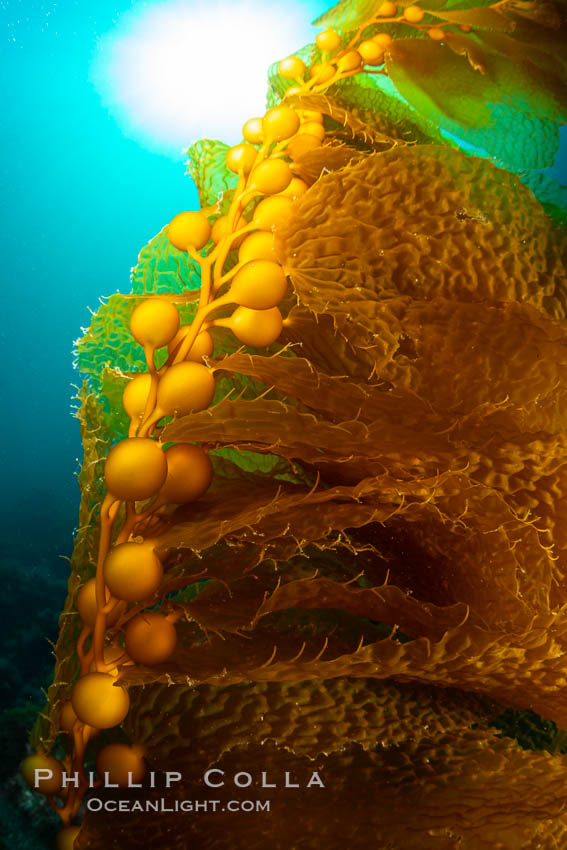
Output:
0,3,567,846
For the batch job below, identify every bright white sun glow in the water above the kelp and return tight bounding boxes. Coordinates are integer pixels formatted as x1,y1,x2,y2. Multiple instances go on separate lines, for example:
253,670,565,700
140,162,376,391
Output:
92,0,324,156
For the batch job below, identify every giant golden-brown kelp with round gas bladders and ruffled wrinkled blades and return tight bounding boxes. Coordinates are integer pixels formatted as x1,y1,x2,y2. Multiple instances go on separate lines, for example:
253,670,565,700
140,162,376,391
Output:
23,0,567,850
